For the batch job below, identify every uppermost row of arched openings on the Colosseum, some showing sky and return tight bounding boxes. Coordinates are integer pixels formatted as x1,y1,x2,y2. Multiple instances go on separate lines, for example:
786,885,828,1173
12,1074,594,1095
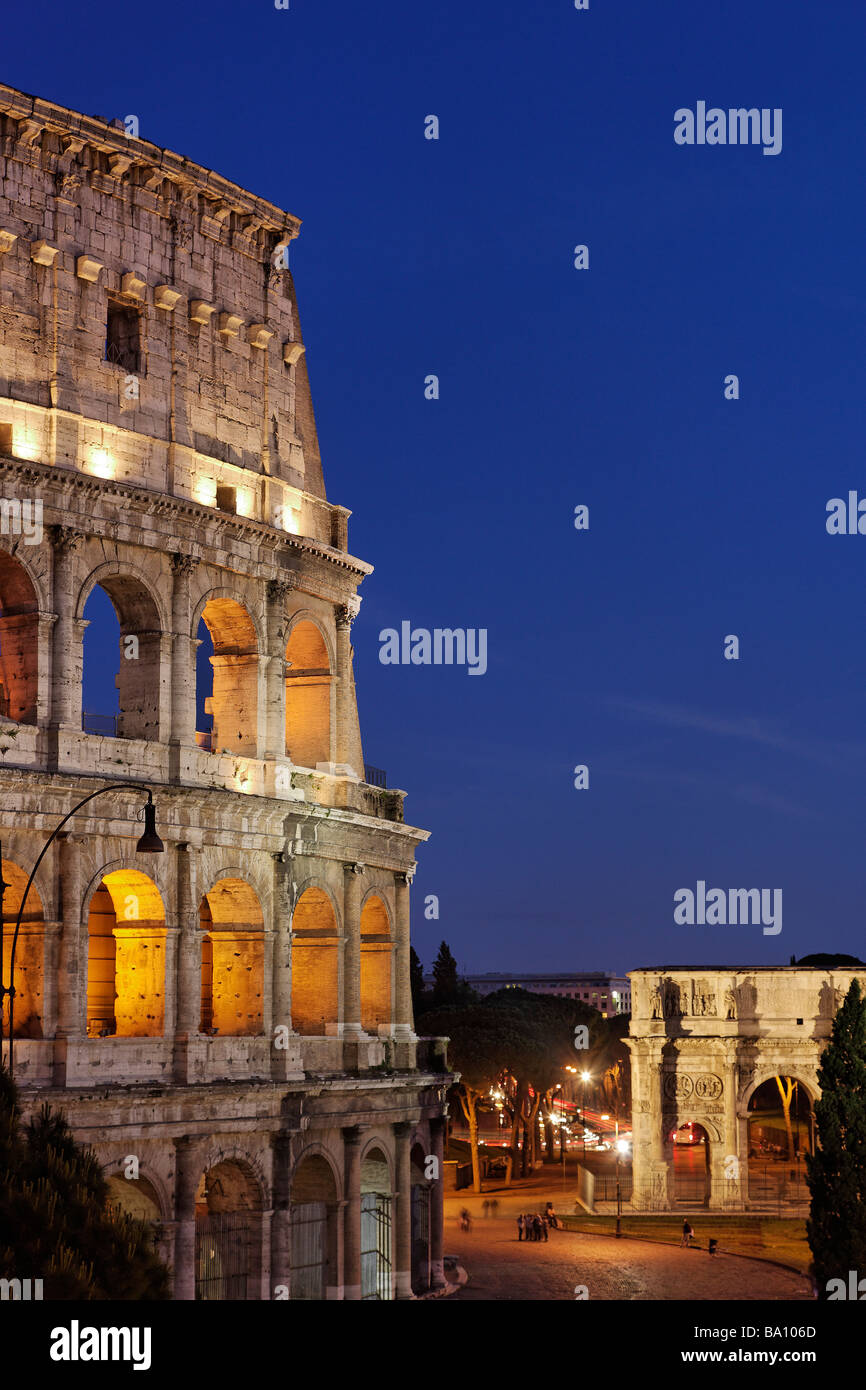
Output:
0,550,335,769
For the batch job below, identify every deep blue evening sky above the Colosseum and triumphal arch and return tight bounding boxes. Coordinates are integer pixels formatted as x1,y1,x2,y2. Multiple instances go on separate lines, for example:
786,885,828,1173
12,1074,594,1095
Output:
8,0,866,970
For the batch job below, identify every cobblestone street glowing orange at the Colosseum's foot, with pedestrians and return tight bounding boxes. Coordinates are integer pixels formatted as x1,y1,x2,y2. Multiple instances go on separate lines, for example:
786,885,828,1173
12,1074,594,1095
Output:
445,1216,810,1302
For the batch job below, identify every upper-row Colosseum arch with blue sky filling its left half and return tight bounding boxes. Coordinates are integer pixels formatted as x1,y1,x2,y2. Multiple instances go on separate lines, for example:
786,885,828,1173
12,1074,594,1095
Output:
82,574,161,742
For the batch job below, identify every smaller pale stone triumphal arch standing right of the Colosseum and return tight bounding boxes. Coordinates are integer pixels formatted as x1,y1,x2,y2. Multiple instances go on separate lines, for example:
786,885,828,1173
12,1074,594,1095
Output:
624,966,866,1211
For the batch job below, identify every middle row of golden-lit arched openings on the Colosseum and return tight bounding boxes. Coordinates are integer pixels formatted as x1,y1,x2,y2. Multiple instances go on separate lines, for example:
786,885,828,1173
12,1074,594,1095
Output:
1,859,393,1038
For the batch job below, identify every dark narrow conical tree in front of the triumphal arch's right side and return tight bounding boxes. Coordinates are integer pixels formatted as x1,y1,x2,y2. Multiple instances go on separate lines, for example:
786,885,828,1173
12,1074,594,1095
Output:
806,980,866,1298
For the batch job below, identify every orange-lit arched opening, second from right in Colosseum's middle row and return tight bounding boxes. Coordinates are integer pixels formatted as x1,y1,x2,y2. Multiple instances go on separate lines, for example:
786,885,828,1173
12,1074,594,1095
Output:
292,888,339,1037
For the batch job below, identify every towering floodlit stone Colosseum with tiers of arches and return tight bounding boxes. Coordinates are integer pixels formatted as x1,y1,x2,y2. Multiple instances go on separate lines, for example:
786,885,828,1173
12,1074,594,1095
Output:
0,88,448,1300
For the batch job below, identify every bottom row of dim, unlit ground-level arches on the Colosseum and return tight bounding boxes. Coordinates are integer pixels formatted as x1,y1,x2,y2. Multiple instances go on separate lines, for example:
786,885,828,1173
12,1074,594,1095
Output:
108,1144,434,1302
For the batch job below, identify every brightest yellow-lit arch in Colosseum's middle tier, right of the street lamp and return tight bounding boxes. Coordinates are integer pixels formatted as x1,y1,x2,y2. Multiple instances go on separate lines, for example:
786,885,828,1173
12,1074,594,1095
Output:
88,869,165,1038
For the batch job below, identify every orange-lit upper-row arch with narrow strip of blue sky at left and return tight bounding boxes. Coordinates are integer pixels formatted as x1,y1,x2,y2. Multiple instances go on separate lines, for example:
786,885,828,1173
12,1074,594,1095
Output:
196,598,259,758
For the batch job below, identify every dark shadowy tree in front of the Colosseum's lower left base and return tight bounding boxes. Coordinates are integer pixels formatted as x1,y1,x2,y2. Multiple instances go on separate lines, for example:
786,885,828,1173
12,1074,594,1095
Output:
0,1068,170,1301
